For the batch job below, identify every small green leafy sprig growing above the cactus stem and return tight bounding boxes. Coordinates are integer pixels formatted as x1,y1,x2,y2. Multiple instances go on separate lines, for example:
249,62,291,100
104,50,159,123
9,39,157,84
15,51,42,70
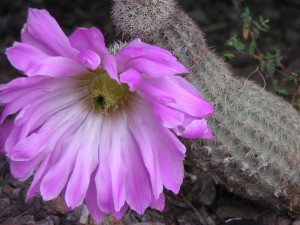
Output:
223,3,300,108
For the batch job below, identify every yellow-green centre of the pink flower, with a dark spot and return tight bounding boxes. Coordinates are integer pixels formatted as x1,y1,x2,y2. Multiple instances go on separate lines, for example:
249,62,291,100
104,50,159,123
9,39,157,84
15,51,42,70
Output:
89,70,130,114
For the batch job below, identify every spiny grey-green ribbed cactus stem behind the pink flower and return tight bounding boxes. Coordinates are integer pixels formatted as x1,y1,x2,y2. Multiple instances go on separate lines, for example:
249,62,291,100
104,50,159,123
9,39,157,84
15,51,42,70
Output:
112,0,300,210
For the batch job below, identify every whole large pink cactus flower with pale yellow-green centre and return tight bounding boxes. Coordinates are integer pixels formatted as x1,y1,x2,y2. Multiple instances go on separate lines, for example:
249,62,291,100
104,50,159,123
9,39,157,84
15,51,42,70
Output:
0,9,214,223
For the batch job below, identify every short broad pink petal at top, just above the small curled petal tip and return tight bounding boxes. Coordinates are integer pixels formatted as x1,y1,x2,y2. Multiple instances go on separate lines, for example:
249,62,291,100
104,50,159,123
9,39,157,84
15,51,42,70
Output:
69,27,109,57
